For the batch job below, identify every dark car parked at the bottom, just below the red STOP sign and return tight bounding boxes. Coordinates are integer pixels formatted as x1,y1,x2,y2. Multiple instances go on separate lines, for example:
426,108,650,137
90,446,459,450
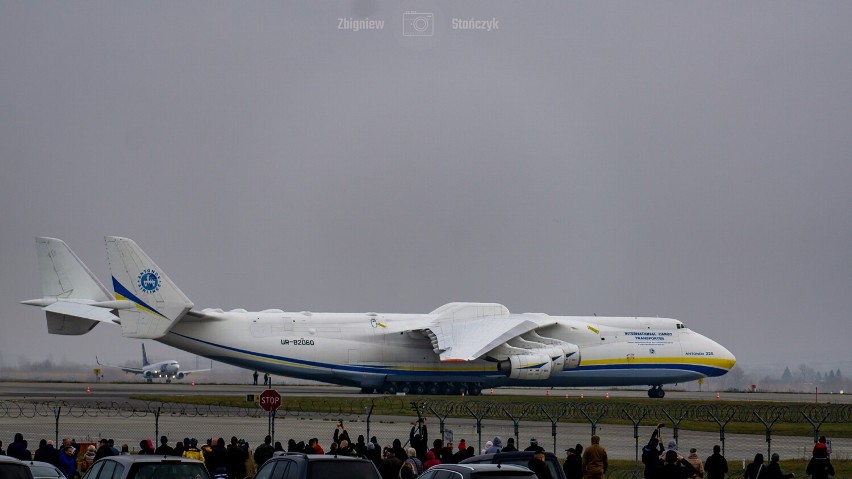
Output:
254,452,381,479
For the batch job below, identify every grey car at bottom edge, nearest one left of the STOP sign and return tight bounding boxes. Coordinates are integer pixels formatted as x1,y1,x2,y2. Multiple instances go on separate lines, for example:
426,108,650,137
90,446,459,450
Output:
78,454,210,479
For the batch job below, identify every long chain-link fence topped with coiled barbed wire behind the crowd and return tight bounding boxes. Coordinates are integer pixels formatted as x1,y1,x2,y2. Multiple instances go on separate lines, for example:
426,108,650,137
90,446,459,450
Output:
0,396,852,477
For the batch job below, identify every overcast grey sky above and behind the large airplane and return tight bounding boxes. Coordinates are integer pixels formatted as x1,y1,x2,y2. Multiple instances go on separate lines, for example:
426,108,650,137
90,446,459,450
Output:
0,0,852,376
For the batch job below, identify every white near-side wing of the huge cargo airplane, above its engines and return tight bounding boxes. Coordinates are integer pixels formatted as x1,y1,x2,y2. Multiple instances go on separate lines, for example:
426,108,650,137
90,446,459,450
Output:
414,303,555,362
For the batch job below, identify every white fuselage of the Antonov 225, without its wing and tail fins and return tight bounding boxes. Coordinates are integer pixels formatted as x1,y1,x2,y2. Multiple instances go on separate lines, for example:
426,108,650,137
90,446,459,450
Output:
160,310,735,392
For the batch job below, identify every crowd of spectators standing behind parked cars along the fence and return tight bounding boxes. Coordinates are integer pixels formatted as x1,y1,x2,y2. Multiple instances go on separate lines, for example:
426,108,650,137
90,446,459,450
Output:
0,424,834,479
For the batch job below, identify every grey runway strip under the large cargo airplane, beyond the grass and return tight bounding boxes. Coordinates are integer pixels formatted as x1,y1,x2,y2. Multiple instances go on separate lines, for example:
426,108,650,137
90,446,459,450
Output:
0,381,852,404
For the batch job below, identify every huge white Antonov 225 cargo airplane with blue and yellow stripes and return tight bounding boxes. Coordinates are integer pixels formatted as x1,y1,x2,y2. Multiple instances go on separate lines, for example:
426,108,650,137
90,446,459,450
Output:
23,236,736,397
